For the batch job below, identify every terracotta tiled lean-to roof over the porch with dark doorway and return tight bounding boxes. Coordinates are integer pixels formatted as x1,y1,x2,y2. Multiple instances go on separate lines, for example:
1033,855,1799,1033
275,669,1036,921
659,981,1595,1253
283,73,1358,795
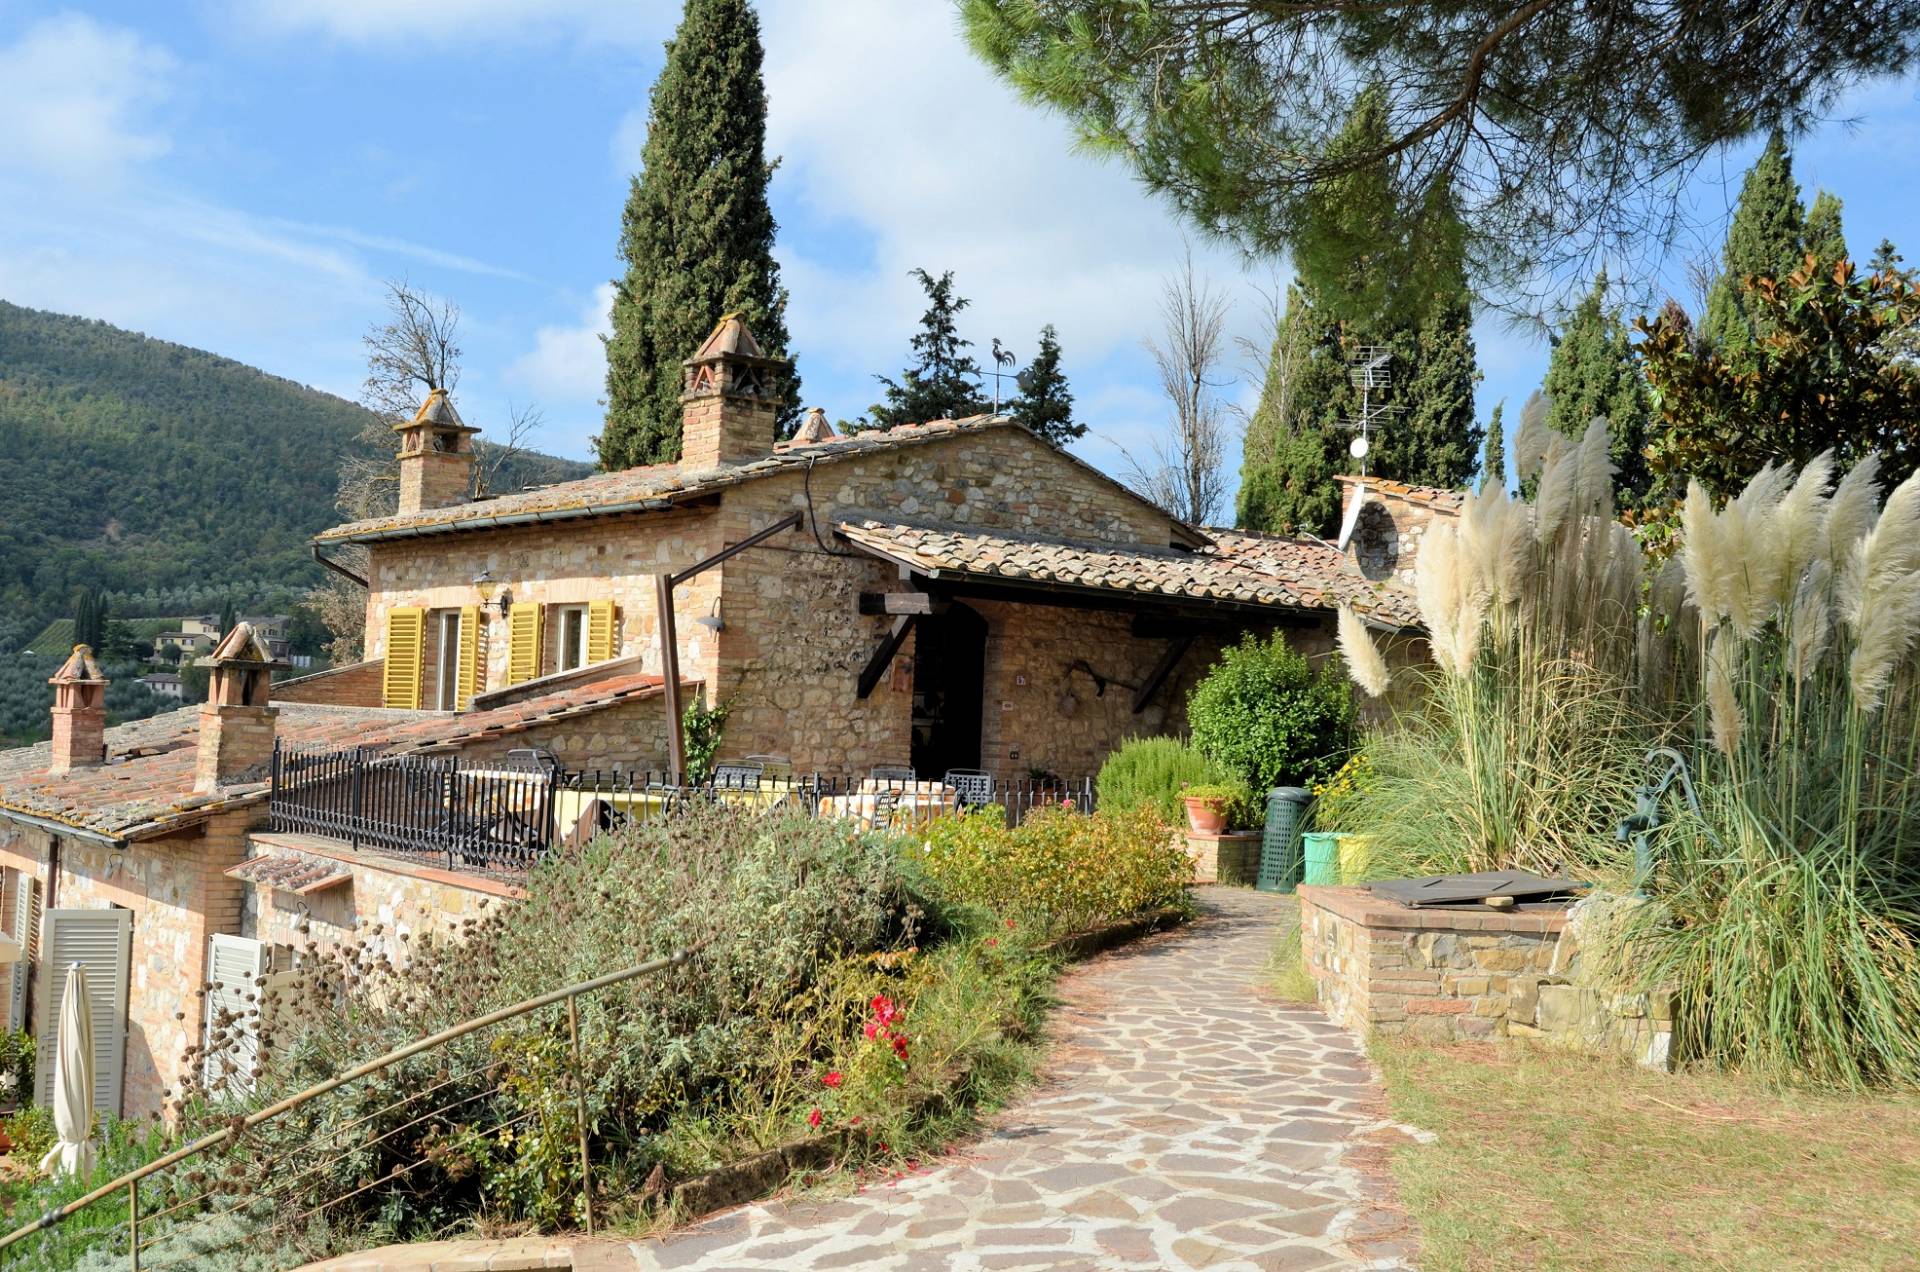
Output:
837,519,1413,626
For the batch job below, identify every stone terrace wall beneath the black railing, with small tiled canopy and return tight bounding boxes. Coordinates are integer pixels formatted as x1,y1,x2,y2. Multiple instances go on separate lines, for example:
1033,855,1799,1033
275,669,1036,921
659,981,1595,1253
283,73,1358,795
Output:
236,834,524,976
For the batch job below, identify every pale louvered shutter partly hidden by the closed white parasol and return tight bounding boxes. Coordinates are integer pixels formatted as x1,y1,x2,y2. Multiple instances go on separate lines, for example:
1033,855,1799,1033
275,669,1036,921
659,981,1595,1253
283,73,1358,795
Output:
33,909,132,1114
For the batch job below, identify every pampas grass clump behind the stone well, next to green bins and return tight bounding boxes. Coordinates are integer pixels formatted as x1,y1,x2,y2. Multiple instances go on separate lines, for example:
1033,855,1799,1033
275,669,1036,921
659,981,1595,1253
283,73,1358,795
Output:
1338,409,1659,876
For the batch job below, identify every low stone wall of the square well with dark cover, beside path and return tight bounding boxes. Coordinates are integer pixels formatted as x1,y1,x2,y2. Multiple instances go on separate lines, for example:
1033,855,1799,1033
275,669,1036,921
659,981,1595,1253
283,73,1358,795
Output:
1298,886,1672,1068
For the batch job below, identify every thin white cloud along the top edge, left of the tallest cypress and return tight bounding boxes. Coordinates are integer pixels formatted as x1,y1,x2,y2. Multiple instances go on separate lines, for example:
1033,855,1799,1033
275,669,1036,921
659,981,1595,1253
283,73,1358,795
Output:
228,0,680,46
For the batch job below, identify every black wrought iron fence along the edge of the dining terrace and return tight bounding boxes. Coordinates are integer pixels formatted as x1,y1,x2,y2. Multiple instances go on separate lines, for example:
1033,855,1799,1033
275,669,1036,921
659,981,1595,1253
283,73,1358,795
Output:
269,747,1096,872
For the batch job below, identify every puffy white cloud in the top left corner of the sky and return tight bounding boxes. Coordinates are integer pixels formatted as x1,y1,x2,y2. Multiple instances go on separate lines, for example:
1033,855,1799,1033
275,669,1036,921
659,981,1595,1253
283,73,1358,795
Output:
0,13,177,183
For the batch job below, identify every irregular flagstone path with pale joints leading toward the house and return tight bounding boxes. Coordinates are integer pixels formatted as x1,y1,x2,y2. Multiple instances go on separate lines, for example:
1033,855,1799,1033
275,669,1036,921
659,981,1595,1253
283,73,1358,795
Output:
622,888,1411,1272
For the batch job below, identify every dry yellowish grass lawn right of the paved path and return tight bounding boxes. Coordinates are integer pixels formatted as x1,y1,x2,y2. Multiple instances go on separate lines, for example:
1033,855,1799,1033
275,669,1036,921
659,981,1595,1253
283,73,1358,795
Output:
1373,1040,1920,1272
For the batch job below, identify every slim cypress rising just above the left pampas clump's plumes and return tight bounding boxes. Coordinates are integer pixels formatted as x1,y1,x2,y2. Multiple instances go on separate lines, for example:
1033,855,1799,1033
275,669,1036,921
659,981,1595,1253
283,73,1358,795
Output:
1546,269,1653,507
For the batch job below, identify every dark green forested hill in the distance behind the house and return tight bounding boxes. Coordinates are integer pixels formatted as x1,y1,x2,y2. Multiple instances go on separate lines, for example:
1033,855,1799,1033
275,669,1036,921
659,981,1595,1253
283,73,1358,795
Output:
0,302,588,637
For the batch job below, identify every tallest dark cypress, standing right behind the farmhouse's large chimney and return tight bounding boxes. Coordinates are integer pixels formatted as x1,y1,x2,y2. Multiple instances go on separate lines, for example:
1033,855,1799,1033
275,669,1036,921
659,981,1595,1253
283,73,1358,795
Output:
597,0,801,469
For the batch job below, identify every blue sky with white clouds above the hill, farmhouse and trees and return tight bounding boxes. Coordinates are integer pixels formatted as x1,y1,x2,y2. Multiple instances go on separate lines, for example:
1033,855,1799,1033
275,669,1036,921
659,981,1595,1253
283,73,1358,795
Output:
0,0,1920,518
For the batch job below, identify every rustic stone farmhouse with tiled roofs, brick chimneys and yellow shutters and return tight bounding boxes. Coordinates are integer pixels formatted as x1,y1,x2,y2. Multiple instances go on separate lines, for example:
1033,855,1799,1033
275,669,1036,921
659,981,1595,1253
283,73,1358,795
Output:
0,317,1459,1114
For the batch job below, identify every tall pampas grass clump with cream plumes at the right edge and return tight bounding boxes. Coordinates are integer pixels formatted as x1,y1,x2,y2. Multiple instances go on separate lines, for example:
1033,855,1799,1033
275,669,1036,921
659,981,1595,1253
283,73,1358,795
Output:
1630,455,1920,1086
